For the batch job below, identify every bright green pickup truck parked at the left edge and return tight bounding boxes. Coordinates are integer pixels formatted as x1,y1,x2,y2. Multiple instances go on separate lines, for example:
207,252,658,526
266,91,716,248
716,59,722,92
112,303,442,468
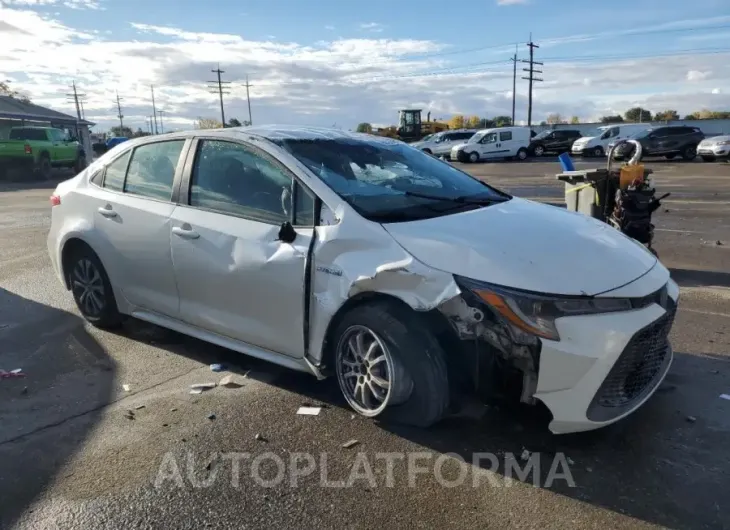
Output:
0,127,86,179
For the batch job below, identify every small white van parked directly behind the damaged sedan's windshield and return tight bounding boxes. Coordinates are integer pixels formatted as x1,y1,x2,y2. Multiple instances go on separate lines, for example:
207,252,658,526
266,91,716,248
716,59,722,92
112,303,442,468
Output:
451,127,532,162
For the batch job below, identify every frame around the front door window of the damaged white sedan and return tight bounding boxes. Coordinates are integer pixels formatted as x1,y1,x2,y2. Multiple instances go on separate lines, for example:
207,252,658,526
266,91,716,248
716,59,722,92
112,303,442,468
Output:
177,135,322,229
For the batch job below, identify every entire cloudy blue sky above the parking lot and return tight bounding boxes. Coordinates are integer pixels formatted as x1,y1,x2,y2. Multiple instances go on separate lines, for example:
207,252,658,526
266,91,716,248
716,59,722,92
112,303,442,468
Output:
0,0,730,132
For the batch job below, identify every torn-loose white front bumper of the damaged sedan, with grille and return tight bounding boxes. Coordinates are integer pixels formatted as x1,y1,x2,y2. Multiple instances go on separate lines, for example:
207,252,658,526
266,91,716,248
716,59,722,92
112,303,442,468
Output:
439,274,679,434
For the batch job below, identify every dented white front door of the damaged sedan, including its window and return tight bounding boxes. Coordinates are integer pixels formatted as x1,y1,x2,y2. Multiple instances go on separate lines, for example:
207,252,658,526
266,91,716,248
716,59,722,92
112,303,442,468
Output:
170,137,314,357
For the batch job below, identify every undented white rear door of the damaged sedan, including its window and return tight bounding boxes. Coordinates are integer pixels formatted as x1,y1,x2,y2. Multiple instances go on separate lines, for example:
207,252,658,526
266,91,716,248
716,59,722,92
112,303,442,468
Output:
87,139,186,317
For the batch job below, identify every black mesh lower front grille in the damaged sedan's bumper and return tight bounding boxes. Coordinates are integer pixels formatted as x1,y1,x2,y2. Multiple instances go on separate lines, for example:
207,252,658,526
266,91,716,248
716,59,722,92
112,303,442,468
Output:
587,298,677,421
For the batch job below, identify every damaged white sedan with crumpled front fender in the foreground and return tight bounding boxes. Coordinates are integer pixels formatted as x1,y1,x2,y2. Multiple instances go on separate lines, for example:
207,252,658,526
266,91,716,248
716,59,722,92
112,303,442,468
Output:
48,127,679,433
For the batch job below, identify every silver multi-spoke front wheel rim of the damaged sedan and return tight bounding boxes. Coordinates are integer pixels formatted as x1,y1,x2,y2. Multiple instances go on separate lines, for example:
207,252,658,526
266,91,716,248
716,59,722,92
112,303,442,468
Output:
337,326,394,416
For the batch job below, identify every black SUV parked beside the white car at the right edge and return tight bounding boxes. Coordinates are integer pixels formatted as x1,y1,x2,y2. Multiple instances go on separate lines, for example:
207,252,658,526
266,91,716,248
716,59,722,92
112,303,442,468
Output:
614,125,705,160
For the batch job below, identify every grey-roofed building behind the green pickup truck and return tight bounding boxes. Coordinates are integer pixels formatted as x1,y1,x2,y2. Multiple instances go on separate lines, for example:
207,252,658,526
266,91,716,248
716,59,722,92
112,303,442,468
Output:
0,96,94,160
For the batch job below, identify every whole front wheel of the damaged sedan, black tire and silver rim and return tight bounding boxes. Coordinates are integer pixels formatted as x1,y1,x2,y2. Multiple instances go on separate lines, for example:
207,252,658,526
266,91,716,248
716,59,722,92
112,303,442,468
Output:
333,301,449,427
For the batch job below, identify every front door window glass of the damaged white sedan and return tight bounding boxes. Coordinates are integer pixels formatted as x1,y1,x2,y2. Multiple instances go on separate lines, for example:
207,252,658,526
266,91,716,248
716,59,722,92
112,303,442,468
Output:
189,140,296,224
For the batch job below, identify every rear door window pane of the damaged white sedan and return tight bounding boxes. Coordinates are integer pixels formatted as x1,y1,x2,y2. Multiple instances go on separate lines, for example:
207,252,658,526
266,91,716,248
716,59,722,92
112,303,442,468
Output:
124,140,185,201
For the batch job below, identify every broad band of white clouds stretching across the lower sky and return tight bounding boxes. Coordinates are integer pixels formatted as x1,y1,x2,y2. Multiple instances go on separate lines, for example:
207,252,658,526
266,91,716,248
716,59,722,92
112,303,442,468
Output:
0,7,730,129
